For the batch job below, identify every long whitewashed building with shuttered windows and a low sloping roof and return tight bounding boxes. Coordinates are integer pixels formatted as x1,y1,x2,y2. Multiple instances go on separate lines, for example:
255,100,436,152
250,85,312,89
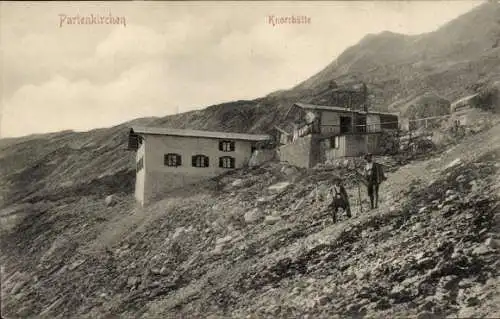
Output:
129,127,270,205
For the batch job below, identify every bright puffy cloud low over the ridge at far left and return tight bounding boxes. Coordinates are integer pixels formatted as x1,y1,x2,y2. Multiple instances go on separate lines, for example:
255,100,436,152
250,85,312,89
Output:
2,65,170,136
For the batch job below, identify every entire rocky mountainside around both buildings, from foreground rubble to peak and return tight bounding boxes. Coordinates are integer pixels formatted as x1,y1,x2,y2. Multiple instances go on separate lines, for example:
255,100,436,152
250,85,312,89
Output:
0,3,500,318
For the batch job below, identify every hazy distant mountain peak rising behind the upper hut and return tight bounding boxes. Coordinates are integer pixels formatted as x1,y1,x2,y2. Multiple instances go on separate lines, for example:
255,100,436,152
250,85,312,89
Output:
293,3,500,112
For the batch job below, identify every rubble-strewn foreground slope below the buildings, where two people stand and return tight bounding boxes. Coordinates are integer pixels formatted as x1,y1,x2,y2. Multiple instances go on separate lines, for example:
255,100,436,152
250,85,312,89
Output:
1,120,500,318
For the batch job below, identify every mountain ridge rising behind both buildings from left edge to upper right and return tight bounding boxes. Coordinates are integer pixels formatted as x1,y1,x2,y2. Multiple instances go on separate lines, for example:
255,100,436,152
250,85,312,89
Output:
0,3,500,209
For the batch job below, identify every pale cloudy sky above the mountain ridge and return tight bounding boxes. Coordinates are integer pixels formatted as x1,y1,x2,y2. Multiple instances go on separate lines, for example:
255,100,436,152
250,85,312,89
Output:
0,1,481,137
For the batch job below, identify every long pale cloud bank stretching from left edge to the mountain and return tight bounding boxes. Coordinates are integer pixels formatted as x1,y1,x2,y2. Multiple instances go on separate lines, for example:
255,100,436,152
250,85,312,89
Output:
2,22,304,136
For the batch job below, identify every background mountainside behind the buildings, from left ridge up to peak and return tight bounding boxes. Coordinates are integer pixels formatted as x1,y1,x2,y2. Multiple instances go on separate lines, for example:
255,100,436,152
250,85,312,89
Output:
0,3,500,207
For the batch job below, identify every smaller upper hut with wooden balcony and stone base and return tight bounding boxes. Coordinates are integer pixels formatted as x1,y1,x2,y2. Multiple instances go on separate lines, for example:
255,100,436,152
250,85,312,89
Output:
279,103,399,167
